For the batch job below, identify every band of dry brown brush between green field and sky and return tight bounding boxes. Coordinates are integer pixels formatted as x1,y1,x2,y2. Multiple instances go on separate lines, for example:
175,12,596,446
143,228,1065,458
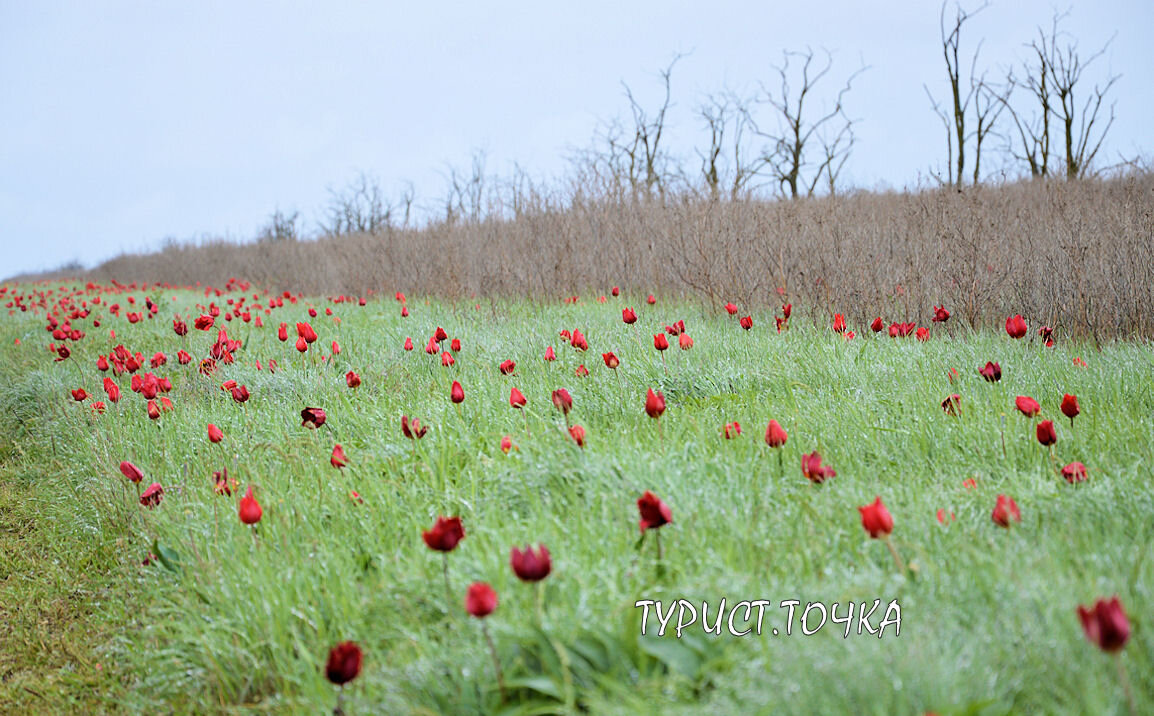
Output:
54,173,1154,340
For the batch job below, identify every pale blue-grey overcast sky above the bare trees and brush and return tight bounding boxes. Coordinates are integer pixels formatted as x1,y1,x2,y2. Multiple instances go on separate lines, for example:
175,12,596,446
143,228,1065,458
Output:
0,0,1154,277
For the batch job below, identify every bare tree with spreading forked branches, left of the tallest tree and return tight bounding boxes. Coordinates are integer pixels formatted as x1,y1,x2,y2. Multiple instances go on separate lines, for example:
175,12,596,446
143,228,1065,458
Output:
752,50,867,199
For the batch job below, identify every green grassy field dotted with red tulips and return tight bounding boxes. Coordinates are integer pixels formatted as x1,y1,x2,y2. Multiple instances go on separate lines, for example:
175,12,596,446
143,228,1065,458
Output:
0,284,1154,714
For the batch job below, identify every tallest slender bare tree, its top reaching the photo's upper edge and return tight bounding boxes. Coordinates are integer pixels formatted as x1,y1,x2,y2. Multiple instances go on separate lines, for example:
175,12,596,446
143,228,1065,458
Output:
923,0,1001,188
